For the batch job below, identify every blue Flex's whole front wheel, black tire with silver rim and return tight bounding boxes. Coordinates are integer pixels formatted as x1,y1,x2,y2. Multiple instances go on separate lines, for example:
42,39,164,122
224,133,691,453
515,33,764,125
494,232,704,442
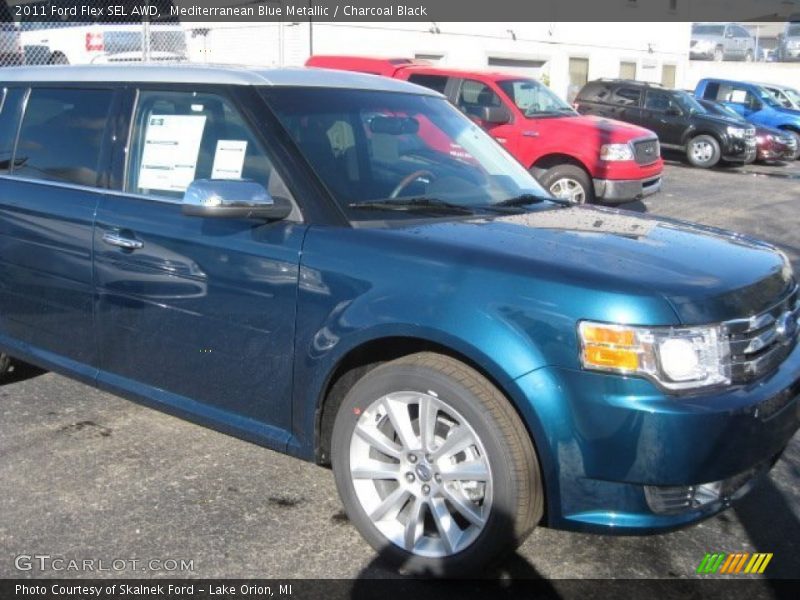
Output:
332,352,544,576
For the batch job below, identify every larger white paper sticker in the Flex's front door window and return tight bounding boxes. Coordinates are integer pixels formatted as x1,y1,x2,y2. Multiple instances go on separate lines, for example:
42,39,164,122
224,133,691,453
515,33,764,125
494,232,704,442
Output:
137,115,206,192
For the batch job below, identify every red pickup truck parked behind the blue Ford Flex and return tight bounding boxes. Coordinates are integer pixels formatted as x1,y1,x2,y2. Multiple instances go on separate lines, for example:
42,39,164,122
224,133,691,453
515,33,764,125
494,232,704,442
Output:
306,56,664,203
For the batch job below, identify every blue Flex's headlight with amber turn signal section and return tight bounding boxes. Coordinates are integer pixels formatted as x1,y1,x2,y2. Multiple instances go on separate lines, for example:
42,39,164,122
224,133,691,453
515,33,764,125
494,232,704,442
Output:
578,321,731,390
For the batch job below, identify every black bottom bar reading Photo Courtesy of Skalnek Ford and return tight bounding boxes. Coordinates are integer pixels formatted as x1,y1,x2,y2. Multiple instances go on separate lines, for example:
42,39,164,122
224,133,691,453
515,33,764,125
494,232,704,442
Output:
0,577,800,600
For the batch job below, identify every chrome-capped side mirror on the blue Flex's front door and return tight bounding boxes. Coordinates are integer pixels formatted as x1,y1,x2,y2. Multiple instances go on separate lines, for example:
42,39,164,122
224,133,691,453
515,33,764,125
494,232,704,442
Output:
181,179,292,221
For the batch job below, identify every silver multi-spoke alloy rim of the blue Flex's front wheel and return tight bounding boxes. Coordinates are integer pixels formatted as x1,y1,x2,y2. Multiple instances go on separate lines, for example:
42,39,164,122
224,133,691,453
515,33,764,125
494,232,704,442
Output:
350,392,492,558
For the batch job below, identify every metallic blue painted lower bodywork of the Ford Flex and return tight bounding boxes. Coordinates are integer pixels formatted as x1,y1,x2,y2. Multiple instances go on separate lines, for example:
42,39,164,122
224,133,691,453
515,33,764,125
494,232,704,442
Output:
0,85,800,532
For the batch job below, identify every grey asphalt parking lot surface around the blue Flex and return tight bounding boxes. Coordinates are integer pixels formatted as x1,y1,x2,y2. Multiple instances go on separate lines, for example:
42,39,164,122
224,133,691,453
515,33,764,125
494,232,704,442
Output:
0,158,800,578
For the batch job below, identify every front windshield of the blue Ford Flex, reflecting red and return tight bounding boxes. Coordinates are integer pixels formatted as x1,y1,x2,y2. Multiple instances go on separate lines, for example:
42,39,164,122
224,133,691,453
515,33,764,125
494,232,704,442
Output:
262,87,550,219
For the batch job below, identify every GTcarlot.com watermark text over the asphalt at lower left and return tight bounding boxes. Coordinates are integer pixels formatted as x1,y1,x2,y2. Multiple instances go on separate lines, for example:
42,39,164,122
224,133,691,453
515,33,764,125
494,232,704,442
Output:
14,554,194,573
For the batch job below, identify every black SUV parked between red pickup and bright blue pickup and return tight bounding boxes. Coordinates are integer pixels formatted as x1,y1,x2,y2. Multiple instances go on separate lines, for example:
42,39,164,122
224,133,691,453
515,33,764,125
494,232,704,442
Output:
575,80,756,168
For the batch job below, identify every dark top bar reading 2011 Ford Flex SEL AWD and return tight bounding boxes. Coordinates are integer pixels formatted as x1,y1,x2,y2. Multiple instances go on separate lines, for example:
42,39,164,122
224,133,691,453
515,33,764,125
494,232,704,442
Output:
0,0,800,23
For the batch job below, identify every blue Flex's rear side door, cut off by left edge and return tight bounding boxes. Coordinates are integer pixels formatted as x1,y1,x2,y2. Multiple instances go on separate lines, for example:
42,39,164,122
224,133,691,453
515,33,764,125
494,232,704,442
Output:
0,86,117,370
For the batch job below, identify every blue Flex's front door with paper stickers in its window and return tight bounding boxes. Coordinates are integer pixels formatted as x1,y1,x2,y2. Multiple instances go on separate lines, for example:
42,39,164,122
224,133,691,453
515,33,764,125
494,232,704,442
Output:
94,86,306,436
